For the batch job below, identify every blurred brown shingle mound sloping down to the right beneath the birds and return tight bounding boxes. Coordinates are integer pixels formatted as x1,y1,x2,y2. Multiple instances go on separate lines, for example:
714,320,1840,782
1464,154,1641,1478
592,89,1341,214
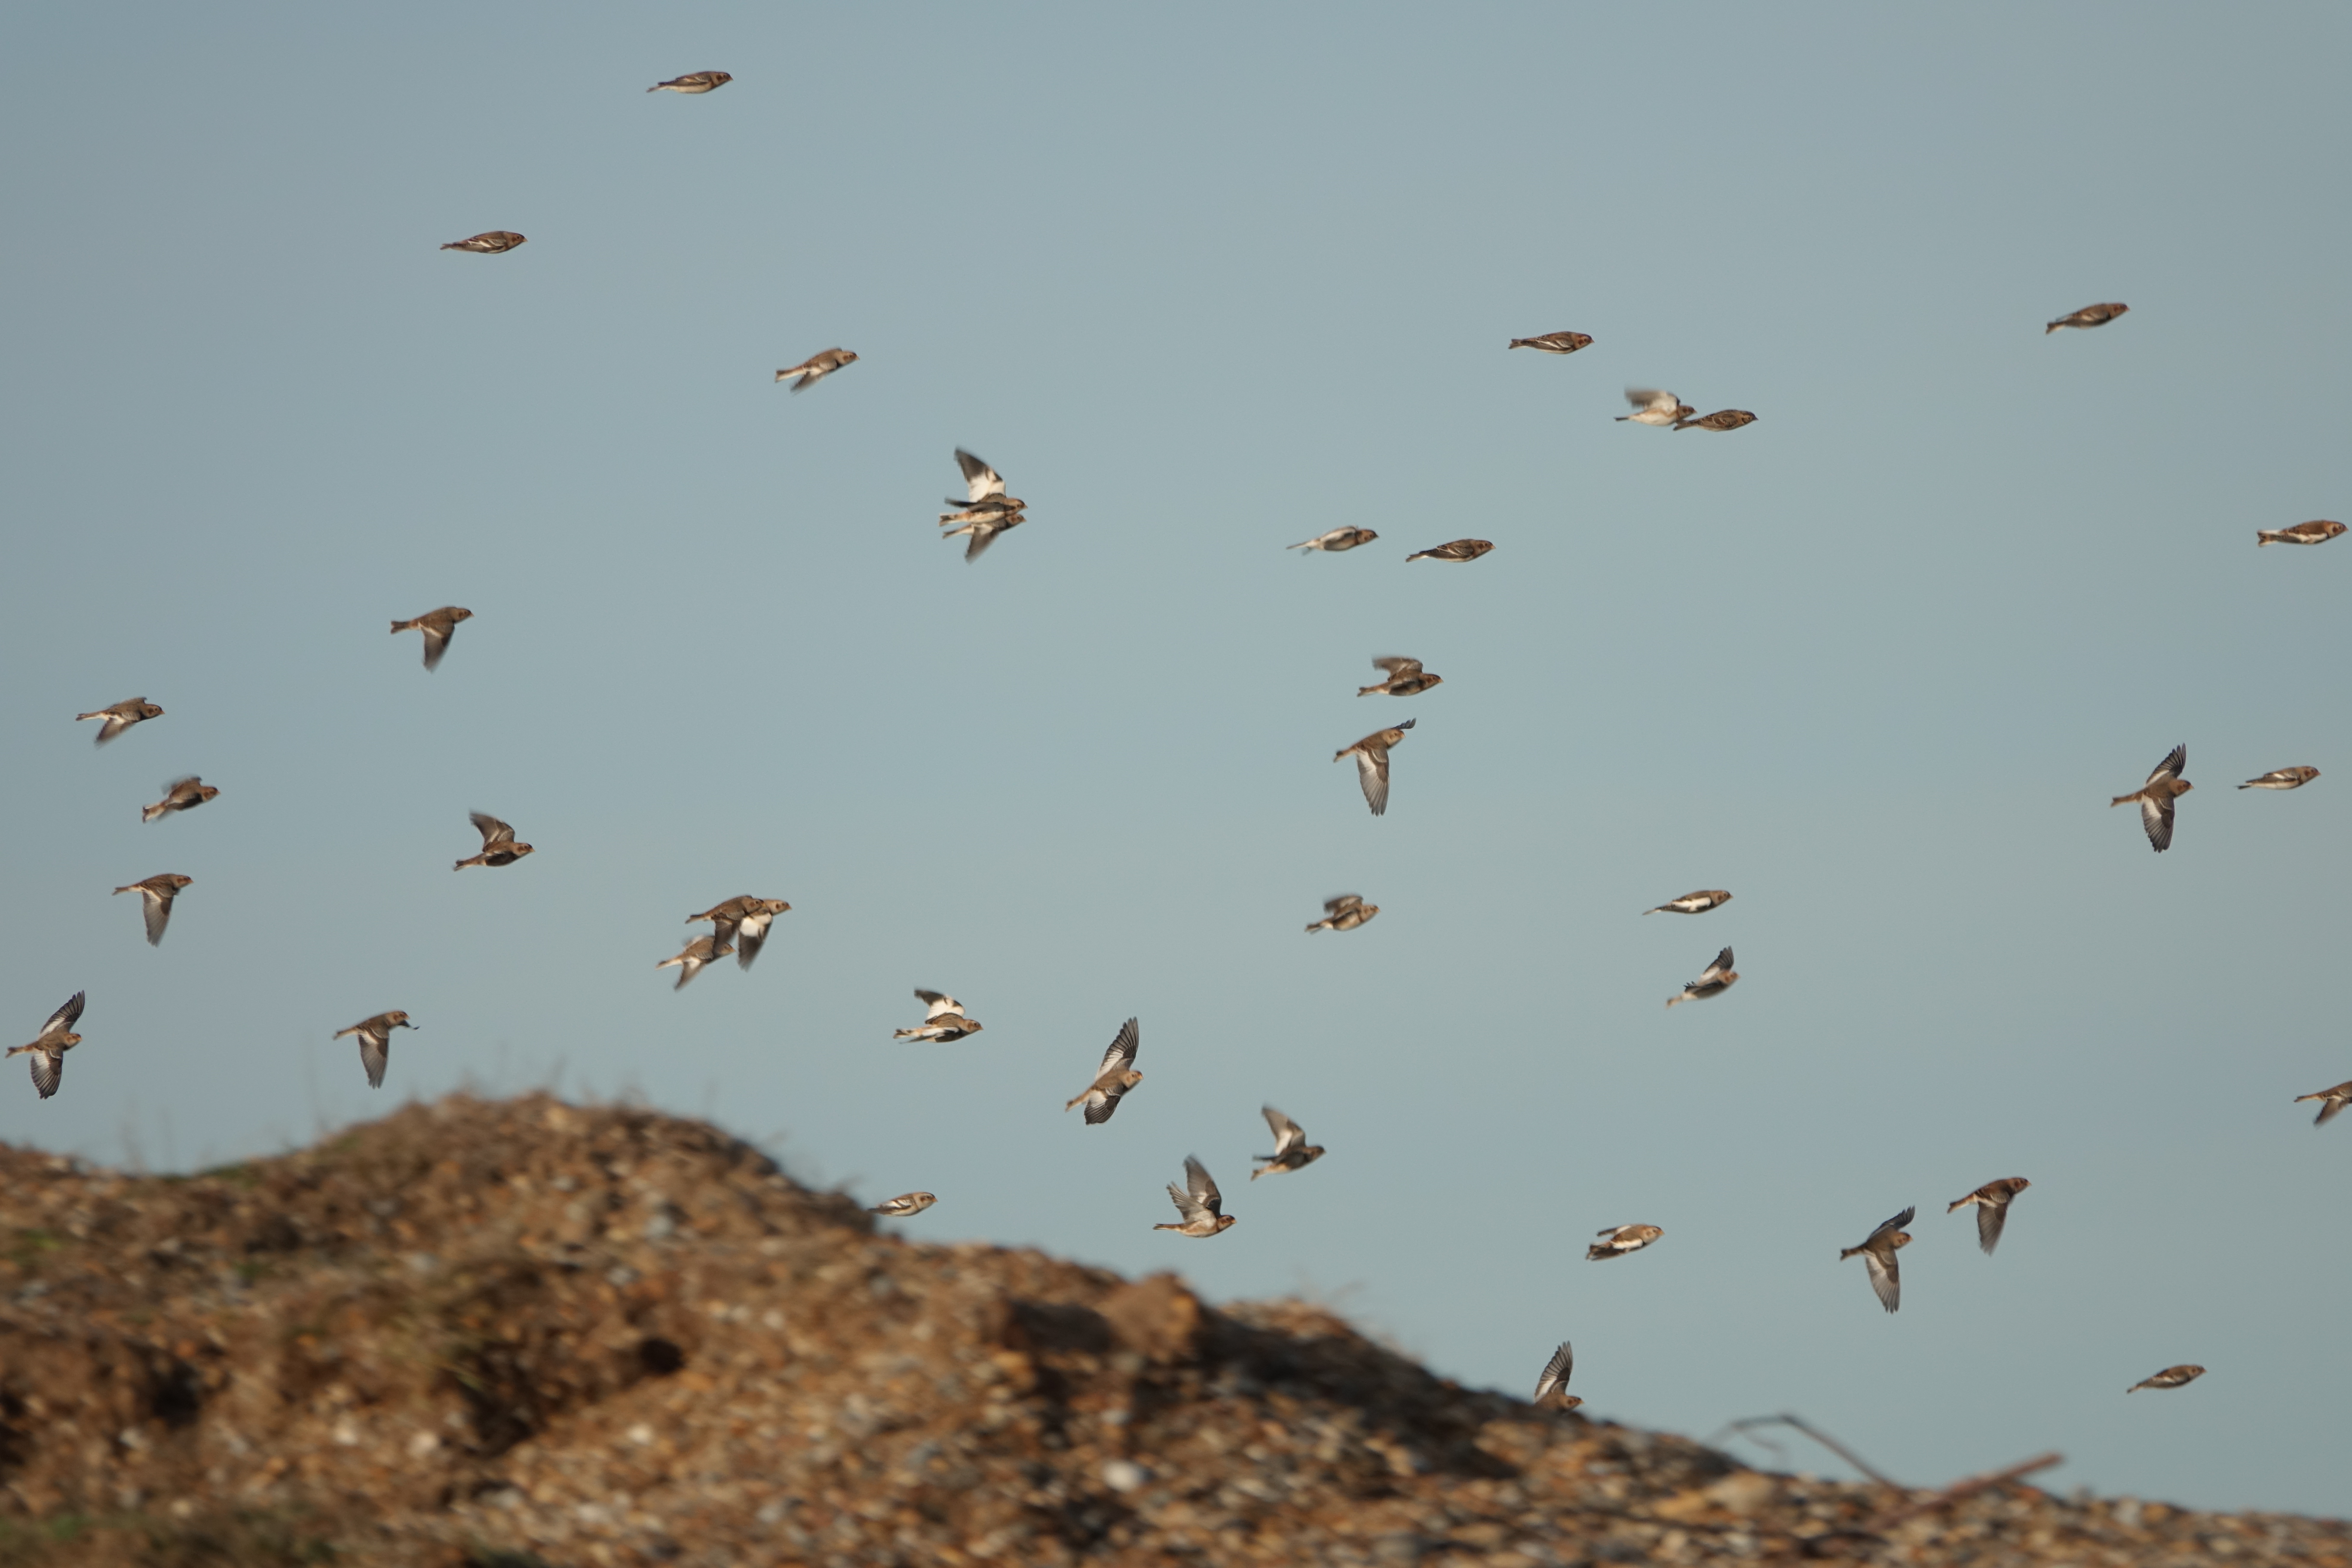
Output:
0,1096,2352,1568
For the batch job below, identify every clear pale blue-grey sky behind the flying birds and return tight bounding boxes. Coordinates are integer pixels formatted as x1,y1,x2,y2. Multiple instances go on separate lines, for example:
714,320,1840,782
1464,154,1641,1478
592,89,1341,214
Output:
0,2,2352,1512
